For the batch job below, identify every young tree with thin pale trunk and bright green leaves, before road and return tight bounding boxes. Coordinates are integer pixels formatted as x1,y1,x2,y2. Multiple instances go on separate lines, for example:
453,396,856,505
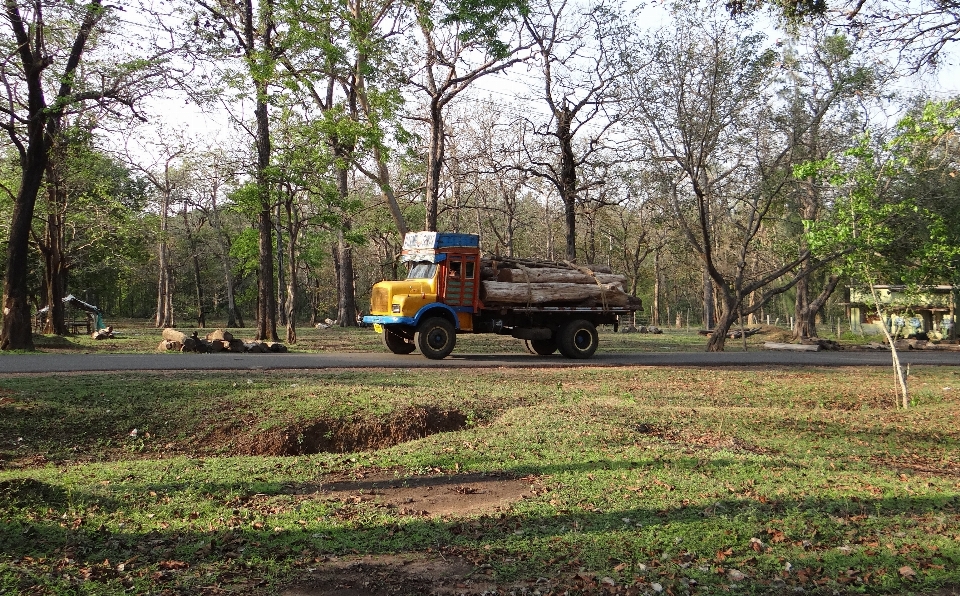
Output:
797,100,960,408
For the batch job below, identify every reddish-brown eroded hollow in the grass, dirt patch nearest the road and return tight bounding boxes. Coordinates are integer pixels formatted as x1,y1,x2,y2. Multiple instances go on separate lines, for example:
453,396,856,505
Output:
201,407,467,456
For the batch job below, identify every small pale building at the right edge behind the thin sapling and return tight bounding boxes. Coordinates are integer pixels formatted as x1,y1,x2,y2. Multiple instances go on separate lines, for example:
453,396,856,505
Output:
847,285,958,340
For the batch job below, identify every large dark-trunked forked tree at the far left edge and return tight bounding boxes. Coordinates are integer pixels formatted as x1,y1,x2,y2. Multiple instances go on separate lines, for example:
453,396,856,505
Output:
0,0,156,350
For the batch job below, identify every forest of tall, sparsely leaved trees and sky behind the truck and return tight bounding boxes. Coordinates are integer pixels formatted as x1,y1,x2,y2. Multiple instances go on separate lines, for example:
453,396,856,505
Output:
0,0,960,350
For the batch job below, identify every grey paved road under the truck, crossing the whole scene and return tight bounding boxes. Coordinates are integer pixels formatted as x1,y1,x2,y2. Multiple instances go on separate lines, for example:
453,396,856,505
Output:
0,351,960,374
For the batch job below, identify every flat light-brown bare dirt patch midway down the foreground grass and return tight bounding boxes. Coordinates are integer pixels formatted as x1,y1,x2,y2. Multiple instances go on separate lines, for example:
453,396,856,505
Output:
291,472,543,516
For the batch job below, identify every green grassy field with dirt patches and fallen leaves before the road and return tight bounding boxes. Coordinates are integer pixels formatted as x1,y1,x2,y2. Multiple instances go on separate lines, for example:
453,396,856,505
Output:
0,360,960,596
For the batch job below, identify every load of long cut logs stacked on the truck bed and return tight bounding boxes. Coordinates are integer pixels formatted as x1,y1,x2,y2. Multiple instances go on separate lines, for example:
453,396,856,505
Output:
480,258,640,308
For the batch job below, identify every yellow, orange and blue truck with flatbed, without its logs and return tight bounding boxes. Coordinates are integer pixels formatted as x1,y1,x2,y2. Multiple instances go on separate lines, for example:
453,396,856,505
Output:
363,232,639,359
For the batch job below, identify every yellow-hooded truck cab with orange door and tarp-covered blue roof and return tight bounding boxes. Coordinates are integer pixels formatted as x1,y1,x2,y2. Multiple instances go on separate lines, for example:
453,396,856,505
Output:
363,232,482,359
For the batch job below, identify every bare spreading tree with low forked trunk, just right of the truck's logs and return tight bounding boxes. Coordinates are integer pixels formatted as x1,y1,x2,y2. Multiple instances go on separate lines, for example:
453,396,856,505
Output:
621,12,819,351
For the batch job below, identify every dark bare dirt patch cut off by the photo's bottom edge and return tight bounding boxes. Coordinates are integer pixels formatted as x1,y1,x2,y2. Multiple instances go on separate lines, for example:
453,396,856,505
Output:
281,554,496,596
